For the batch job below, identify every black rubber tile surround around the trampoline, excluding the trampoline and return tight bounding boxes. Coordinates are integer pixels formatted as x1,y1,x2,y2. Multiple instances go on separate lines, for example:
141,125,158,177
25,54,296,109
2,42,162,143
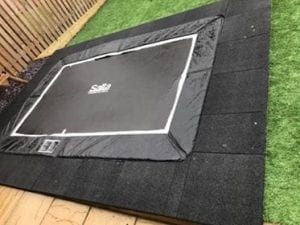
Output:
0,0,270,225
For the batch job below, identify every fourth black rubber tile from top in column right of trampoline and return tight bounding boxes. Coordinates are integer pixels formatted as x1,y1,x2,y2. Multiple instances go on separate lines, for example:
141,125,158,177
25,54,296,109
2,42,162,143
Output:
203,69,267,114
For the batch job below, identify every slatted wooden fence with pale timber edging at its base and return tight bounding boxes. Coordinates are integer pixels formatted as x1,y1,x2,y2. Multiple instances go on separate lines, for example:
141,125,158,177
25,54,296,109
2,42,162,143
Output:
0,0,105,80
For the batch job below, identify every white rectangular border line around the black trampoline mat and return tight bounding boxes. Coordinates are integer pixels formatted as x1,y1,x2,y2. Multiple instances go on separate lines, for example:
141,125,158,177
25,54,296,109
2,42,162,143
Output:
10,34,198,137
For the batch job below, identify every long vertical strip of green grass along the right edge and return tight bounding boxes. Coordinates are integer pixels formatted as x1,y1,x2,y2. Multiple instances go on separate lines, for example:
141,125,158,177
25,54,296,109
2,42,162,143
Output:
264,0,300,225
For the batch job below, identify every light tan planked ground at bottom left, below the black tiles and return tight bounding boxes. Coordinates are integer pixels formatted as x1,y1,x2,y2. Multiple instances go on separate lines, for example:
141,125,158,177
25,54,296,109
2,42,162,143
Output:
0,186,272,225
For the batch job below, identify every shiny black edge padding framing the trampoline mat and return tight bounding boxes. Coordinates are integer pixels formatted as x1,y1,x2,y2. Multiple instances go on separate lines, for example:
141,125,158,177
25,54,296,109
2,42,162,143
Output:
0,16,223,161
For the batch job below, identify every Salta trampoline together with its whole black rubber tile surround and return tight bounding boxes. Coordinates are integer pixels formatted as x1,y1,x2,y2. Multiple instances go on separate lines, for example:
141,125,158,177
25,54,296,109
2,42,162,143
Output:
0,0,270,225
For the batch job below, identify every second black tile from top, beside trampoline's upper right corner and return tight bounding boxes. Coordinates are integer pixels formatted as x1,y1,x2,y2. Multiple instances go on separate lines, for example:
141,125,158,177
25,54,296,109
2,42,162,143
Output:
219,8,270,43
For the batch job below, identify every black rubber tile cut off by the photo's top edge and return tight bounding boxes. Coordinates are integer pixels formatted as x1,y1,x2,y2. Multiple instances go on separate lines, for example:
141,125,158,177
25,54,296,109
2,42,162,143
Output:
226,0,271,17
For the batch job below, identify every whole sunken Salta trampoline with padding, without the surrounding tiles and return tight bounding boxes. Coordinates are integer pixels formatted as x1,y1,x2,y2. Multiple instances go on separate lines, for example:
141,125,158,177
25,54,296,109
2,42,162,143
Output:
1,16,223,161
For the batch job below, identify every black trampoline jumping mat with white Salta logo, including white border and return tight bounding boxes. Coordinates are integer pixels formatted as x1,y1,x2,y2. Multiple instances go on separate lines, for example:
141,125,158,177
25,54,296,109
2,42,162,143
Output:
12,35,196,137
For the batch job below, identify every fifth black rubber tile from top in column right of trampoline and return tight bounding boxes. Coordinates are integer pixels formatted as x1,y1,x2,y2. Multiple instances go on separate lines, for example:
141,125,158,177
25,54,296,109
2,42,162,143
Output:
193,113,265,154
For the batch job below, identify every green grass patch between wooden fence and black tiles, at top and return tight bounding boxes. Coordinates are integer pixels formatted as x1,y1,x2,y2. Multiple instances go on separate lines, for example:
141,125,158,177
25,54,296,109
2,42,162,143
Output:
69,0,213,45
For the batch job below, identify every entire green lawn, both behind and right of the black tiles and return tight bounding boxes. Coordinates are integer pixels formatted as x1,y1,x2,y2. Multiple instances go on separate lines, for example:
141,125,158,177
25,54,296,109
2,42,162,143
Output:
70,0,300,225
